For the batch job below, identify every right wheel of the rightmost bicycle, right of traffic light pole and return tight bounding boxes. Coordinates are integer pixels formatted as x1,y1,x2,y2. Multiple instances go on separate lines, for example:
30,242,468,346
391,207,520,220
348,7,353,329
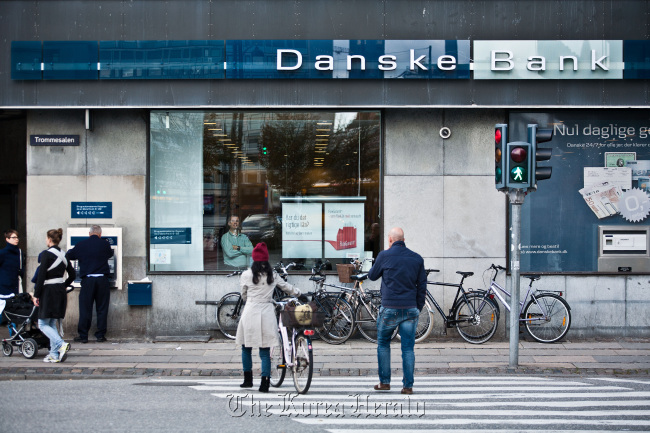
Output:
524,293,571,343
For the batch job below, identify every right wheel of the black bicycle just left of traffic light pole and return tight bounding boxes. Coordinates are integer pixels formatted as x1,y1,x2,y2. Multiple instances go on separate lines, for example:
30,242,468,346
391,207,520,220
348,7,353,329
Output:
454,293,499,344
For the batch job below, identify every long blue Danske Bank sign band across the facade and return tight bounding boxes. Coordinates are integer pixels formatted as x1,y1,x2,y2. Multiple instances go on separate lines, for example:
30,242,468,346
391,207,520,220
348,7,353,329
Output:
11,40,650,80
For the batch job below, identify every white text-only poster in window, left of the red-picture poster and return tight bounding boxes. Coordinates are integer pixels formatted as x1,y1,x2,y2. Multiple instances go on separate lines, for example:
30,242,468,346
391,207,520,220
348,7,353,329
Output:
282,203,323,258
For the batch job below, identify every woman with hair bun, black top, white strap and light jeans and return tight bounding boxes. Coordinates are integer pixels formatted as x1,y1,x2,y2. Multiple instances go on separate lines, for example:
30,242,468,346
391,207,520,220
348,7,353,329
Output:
34,229,76,362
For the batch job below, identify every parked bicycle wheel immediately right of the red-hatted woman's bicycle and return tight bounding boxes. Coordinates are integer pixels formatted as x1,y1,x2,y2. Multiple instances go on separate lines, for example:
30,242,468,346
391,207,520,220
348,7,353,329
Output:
315,295,354,344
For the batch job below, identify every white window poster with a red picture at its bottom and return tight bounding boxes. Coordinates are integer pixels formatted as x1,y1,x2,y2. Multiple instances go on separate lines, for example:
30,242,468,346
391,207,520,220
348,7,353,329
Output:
325,203,363,259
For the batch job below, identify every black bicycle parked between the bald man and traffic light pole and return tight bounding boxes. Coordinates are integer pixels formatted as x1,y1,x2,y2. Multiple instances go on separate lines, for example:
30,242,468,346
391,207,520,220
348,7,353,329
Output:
416,269,500,344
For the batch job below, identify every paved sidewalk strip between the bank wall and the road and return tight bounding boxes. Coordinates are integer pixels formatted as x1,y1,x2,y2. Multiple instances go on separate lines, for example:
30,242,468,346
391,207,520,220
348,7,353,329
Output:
0,338,650,380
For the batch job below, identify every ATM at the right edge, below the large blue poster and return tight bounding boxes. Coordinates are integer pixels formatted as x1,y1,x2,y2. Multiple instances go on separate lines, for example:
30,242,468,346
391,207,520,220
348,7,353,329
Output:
598,226,650,272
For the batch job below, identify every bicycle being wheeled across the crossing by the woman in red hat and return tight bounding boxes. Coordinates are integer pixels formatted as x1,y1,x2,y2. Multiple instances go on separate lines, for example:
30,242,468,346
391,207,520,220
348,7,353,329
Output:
270,298,314,394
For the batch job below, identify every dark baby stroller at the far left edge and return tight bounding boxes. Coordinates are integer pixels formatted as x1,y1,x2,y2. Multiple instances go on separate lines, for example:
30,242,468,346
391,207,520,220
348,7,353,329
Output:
2,293,50,359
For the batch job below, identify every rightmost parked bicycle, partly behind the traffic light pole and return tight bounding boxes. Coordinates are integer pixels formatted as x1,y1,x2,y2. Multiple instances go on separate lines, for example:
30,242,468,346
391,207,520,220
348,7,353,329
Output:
477,264,571,343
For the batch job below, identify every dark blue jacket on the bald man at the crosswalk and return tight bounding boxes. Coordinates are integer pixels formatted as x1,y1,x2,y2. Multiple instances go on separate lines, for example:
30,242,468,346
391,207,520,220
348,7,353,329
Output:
368,241,427,310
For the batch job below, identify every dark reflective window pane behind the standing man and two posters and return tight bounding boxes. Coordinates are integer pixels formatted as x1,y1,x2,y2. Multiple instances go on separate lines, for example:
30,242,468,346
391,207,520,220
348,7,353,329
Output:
197,112,380,270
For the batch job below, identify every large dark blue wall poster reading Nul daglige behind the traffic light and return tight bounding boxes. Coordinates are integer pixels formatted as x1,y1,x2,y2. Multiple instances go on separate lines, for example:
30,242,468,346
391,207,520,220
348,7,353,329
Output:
508,110,650,273
